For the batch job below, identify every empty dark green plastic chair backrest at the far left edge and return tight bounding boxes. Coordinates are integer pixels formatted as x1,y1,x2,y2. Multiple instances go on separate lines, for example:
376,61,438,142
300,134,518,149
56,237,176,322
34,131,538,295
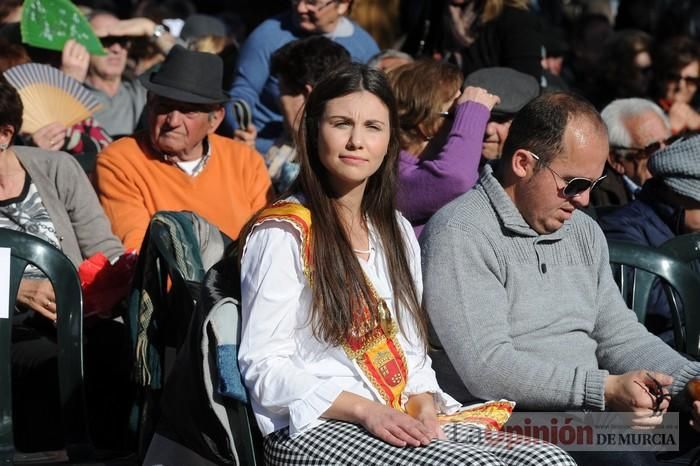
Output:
0,229,94,464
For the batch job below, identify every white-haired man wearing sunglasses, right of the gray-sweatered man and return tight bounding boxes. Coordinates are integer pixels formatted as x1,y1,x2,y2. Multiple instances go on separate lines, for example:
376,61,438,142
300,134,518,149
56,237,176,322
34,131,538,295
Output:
591,98,671,207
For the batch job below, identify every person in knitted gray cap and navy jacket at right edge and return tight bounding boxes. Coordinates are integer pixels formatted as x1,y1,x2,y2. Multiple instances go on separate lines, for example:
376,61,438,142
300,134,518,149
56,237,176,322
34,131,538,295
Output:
599,135,700,343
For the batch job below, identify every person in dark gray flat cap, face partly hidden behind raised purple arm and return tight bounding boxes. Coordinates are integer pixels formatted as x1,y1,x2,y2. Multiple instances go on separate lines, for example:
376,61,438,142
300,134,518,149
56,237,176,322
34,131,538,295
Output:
464,67,540,161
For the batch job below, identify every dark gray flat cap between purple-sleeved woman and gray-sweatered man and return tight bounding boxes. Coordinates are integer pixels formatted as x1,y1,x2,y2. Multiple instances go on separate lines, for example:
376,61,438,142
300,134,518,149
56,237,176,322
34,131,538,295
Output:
464,67,540,114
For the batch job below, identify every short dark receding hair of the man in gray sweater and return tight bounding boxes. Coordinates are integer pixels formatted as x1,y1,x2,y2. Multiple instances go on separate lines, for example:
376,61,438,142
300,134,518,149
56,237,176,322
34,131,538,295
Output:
503,92,607,165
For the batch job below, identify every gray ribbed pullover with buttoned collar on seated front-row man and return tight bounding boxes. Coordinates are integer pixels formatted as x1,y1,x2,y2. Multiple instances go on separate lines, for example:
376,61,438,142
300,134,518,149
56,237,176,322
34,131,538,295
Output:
421,167,700,410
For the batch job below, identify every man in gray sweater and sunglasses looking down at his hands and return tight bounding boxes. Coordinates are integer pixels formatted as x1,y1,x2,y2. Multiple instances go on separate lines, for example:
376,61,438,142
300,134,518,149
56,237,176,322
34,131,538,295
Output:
421,92,700,465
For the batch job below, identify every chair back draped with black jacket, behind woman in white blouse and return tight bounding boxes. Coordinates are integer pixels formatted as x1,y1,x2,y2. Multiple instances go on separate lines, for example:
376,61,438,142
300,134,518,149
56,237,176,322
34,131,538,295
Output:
147,245,263,466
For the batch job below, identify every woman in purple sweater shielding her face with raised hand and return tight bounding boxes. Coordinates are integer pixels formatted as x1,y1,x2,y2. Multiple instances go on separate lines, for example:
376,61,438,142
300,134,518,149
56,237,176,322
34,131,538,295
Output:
389,60,499,236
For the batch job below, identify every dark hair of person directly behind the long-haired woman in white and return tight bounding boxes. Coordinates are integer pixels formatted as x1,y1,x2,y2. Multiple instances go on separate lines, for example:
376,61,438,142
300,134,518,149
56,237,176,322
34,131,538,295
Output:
270,36,351,95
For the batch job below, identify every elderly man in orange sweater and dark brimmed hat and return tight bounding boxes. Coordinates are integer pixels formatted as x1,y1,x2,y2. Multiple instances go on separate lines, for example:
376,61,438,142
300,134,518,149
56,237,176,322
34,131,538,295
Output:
97,45,271,249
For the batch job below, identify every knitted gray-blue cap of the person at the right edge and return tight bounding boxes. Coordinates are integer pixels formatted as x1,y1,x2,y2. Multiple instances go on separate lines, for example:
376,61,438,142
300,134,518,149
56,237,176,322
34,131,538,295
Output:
649,136,700,202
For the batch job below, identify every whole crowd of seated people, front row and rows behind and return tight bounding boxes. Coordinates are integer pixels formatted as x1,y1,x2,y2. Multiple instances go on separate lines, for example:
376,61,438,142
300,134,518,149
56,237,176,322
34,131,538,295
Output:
0,0,700,465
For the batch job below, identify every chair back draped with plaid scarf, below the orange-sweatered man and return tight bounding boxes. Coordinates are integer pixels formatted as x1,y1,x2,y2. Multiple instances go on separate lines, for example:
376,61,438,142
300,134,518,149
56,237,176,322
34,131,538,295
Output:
127,211,227,459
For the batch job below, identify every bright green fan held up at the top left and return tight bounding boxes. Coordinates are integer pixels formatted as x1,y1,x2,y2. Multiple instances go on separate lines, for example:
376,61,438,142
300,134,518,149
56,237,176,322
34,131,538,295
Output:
20,0,107,55
